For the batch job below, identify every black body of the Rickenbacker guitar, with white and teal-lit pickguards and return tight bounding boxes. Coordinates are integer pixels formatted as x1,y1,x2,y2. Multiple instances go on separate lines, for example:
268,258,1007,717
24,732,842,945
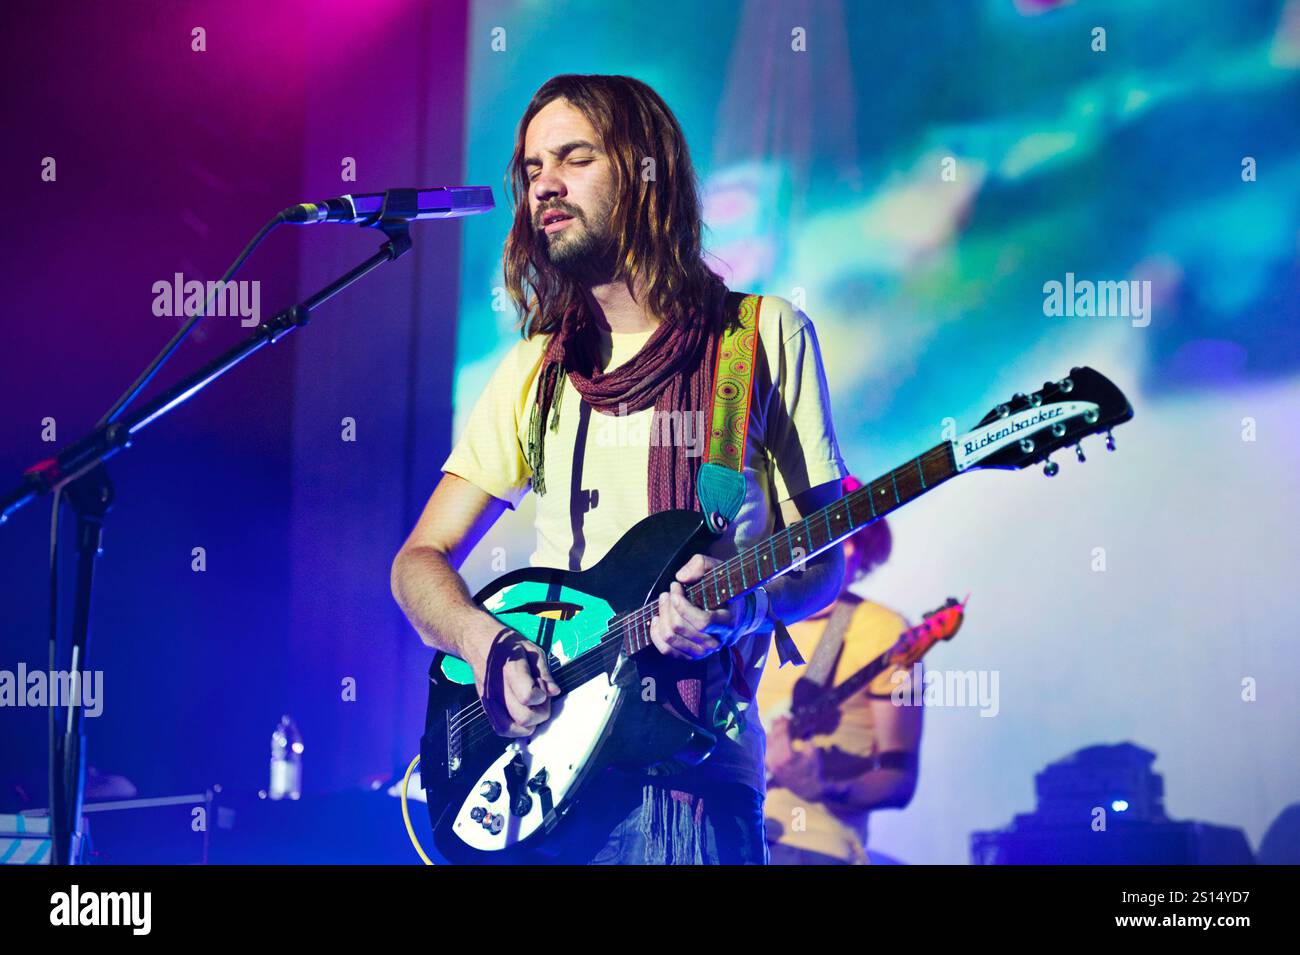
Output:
420,511,716,864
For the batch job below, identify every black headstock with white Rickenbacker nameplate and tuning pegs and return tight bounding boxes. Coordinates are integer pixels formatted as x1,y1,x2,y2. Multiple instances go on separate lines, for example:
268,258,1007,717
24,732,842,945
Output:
953,368,1134,477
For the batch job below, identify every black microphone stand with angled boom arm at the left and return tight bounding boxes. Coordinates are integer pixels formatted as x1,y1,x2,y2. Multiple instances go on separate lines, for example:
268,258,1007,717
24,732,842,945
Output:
0,190,417,865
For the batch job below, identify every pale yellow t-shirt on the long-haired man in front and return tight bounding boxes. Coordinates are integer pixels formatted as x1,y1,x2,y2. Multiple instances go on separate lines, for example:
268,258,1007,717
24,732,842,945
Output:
442,295,848,791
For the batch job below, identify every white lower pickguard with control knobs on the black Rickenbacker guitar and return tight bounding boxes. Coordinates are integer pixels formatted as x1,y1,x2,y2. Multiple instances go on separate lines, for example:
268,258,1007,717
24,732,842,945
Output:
452,673,623,852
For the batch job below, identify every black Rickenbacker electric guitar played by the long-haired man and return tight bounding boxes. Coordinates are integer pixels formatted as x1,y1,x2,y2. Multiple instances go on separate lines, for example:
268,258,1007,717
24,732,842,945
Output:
420,368,1132,864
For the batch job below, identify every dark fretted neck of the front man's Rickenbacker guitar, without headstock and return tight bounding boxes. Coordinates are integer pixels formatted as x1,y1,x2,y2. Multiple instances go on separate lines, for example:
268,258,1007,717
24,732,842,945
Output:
623,442,957,654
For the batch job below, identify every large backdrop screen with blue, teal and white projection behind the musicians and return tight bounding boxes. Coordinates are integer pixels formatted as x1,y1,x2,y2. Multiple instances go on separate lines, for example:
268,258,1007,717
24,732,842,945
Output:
455,0,1300,863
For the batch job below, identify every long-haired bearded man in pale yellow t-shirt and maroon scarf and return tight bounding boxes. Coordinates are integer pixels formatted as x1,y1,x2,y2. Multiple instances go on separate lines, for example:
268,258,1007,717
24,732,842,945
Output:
393,75,846,864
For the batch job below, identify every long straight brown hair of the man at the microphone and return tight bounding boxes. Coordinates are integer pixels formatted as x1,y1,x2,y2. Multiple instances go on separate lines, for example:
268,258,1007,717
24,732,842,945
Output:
502,73,724,338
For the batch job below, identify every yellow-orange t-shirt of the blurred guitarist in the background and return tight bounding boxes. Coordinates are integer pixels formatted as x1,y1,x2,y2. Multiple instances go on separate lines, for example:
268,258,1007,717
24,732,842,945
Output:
758,600,907,864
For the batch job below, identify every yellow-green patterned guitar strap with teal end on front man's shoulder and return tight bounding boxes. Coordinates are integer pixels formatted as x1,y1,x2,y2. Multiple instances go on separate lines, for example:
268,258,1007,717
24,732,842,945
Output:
696,292,803,685
